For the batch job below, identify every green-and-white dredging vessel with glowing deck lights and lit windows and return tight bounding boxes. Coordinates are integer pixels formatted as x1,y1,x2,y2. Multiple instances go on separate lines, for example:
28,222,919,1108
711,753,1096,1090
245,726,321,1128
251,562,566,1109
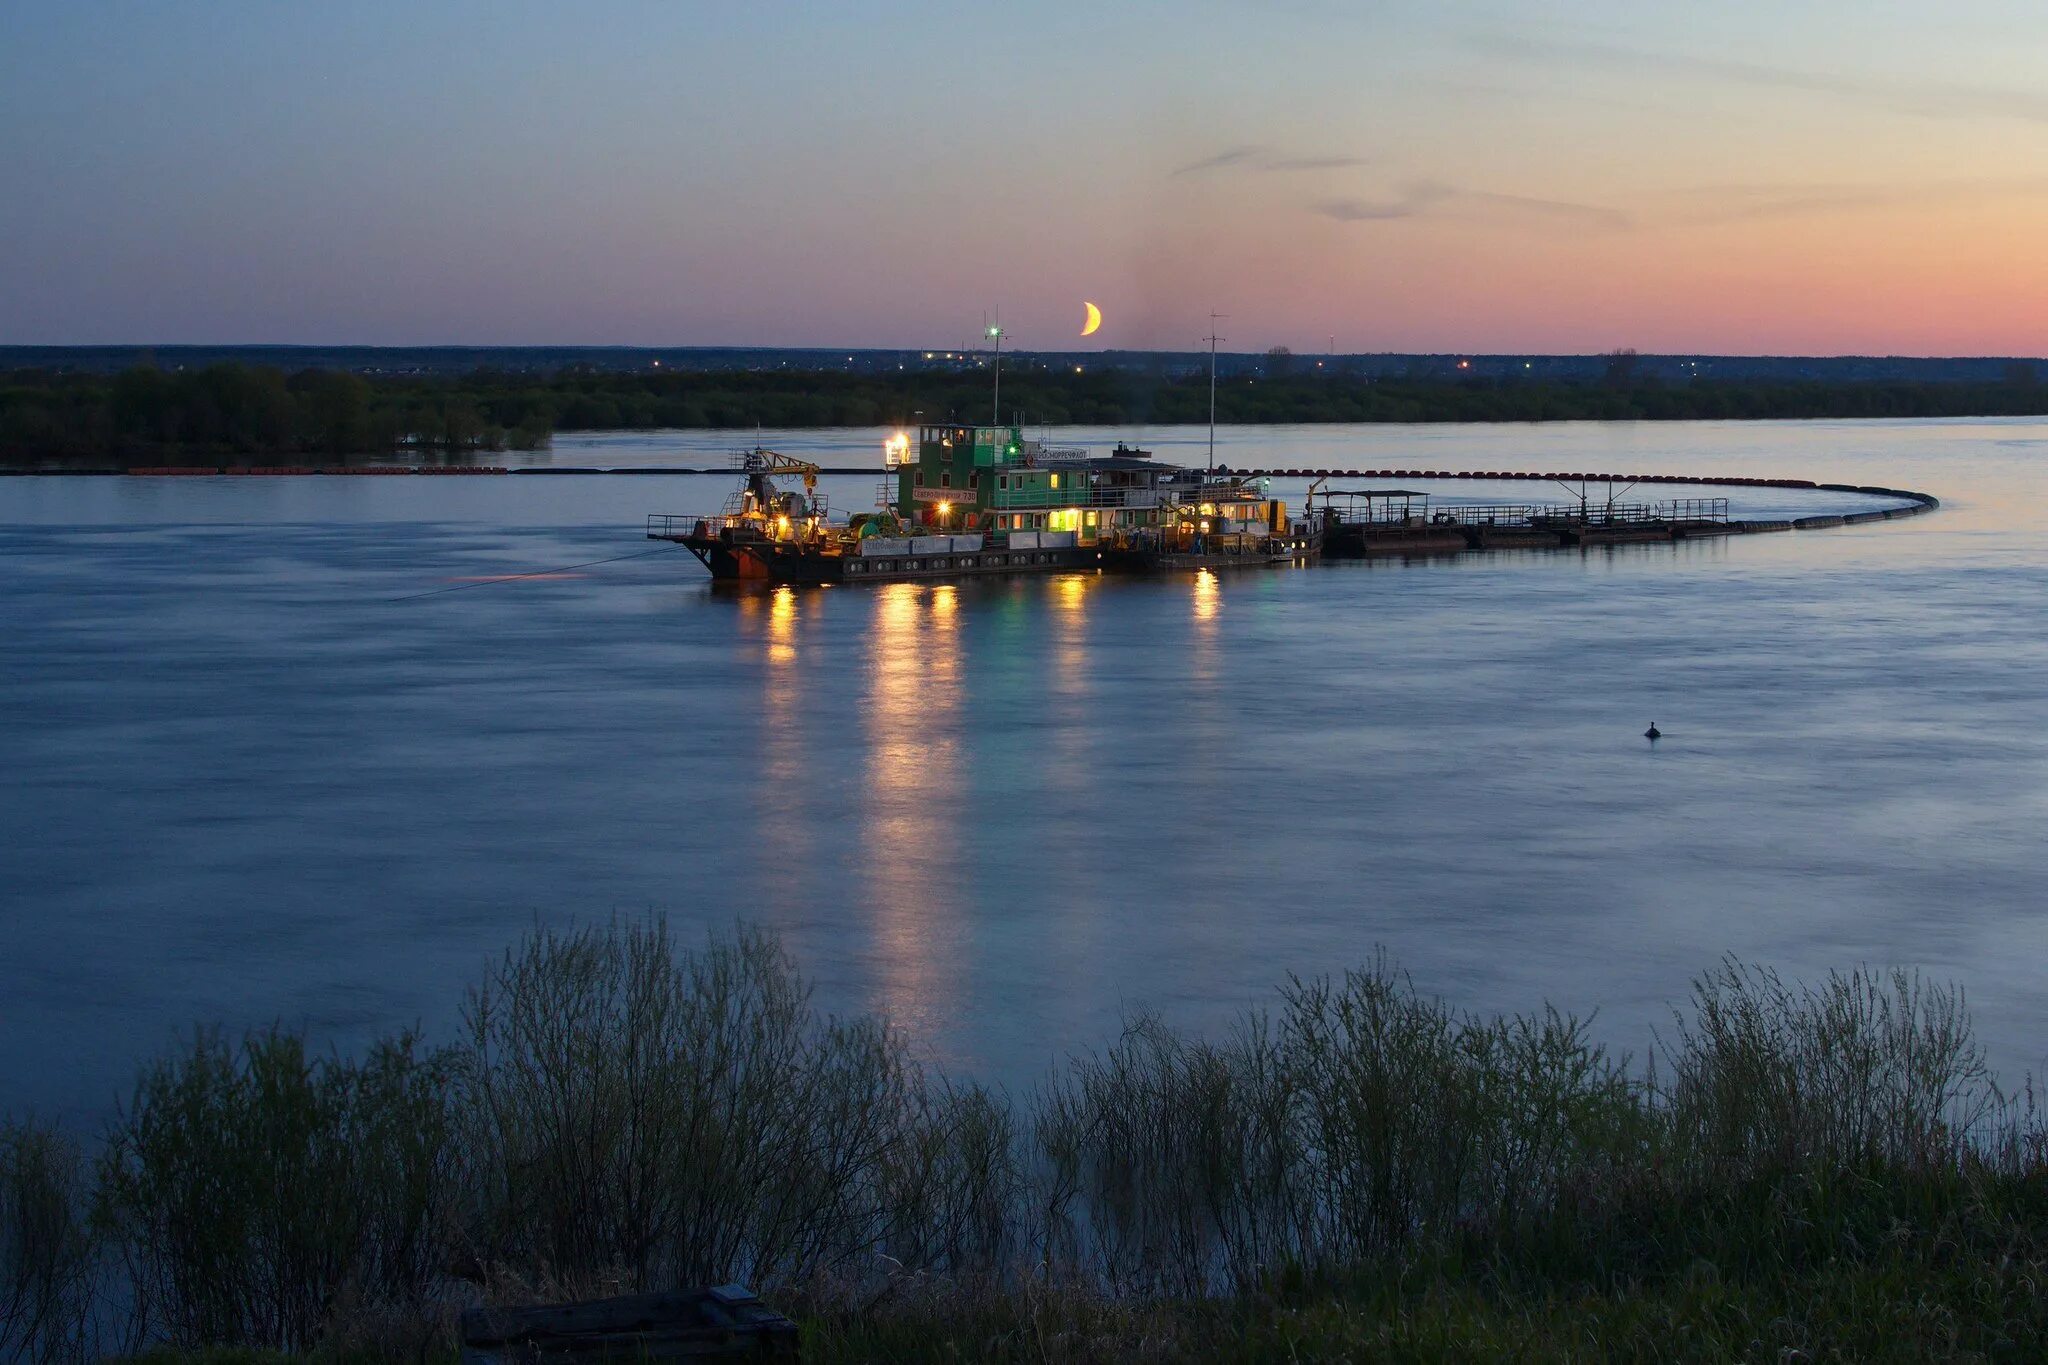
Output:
647,424,1323,583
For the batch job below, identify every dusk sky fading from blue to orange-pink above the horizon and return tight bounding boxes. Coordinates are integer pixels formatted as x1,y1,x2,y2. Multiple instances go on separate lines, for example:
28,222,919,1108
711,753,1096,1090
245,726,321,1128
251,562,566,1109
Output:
0,0,2048,354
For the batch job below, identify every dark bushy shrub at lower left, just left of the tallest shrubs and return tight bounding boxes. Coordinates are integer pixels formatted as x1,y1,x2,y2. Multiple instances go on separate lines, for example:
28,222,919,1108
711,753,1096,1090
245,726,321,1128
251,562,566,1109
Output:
98,1029,455,1351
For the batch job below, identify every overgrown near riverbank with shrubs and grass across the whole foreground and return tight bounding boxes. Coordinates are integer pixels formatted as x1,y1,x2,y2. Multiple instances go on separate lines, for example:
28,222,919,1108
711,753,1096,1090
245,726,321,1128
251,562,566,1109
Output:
0,921,2048,1361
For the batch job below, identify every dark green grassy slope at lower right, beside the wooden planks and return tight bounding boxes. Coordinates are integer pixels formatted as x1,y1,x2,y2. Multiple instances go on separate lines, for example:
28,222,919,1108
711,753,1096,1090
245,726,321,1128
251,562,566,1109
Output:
805,1171,2048,1363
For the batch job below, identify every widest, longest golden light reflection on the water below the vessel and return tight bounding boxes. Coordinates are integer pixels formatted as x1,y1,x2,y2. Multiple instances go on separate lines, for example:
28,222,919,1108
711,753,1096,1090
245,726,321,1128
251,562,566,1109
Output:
856,583,971,1031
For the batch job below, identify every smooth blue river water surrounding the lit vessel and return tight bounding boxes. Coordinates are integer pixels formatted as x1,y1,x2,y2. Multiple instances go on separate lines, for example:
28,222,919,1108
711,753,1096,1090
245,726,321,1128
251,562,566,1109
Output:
0,422,2048,1121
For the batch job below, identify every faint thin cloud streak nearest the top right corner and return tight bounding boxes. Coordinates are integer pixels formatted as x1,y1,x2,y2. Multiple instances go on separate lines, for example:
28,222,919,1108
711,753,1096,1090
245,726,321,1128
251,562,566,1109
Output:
1468,35,2048,123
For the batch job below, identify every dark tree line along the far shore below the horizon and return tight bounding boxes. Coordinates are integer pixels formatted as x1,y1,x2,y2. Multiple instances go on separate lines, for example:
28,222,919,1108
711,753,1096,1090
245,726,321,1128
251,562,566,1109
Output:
0,352,2048,463
